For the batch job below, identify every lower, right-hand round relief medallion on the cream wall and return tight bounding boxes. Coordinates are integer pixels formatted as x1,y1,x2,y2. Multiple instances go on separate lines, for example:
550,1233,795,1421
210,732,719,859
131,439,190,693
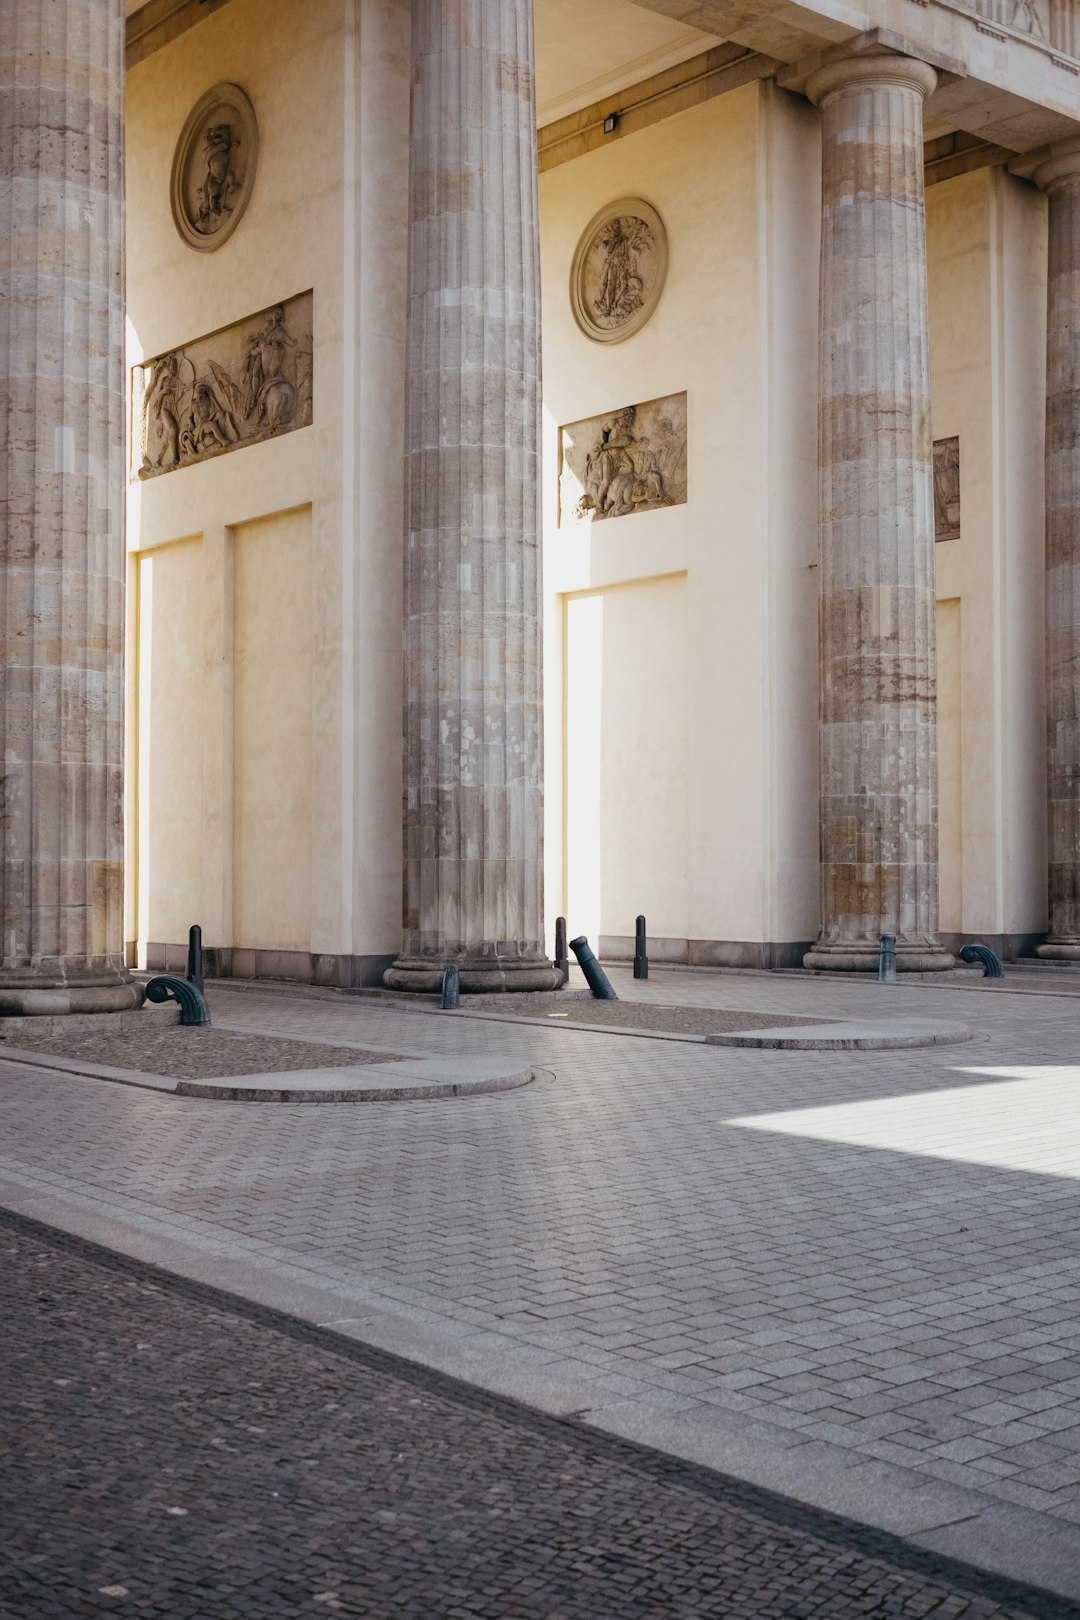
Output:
570,198,667,343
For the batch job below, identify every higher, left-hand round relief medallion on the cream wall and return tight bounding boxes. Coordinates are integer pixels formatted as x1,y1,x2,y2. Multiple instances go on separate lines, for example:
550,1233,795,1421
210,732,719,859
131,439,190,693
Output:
172,84,259,253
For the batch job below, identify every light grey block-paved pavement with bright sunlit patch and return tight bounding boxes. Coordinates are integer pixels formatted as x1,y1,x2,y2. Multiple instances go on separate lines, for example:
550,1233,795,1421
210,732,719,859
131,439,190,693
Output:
0,972,1080,1612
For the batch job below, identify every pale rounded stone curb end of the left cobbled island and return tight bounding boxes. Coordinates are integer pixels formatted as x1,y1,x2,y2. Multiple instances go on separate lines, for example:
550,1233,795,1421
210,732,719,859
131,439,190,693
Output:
173,1056,551,1103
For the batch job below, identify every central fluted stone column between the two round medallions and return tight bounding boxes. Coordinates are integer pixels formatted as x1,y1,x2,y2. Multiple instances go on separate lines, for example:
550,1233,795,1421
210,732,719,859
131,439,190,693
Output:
385,0,559,990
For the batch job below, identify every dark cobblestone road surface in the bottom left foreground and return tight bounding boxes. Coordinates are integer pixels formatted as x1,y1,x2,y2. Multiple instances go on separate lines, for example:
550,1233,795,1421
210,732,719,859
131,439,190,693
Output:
0,1217,1069,1620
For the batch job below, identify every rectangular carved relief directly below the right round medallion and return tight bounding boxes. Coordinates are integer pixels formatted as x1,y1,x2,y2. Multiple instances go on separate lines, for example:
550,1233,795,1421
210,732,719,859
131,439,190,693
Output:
559,394,687,525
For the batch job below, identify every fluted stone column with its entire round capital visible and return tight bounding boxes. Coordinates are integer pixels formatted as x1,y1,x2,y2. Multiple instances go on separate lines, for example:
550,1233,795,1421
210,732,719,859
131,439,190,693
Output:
805,52,952,970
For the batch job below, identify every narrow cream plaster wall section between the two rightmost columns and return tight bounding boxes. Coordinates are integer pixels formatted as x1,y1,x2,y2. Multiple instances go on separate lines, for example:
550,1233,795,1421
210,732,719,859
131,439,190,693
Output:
926,168,1046,936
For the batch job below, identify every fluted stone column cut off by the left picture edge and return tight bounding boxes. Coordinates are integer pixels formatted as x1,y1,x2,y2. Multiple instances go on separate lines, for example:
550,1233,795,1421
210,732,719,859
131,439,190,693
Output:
0,0,141,1014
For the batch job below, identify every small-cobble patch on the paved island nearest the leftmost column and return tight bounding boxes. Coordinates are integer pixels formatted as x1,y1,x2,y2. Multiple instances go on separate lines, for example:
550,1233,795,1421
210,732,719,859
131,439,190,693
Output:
0,1024,397,1081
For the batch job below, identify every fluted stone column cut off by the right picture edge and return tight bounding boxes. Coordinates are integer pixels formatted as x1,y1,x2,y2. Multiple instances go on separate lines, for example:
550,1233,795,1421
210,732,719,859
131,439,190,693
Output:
1035,139,1080,961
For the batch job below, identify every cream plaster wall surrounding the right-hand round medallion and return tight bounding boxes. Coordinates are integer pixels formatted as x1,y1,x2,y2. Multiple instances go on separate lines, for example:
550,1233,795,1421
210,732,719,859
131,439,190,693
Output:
541,84,819,941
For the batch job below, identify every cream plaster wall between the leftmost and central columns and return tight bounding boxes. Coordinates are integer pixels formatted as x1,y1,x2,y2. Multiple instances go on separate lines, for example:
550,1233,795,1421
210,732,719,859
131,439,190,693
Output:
126,0,408,956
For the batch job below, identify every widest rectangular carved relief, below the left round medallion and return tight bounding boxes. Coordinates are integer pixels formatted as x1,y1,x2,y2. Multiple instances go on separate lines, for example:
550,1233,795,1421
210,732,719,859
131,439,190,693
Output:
131,292,313,478
